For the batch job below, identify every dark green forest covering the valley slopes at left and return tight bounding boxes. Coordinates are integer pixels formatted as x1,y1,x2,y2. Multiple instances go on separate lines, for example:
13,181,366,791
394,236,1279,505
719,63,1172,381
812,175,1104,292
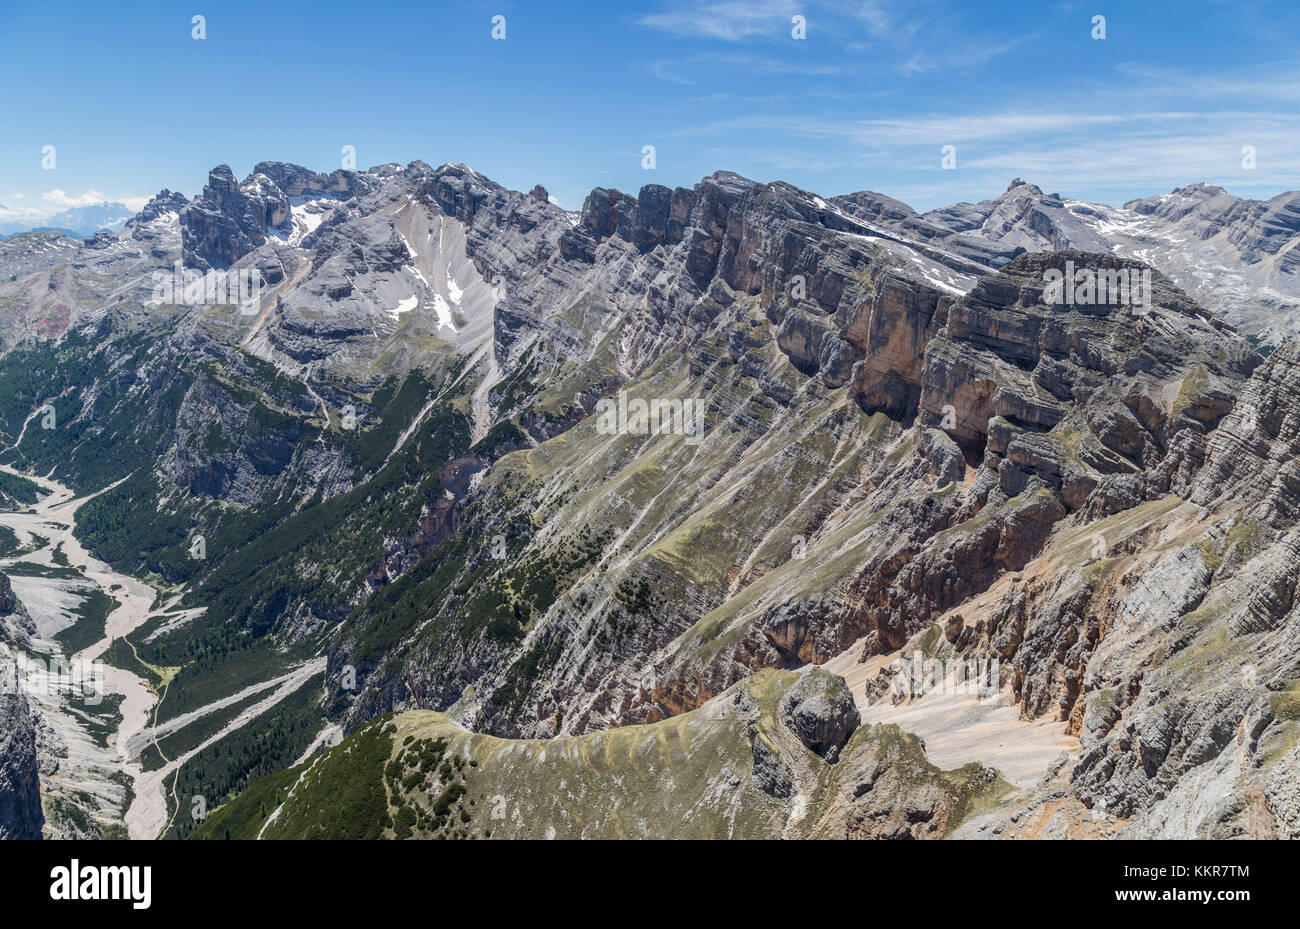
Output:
0,313,488,834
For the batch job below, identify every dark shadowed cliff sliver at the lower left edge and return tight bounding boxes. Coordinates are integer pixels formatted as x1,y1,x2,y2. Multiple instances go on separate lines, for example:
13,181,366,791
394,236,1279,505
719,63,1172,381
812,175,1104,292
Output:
0,574,44,839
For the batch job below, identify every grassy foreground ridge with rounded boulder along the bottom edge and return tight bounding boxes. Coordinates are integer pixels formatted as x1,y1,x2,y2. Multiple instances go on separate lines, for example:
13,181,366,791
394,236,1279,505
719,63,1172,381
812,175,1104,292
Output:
195,672,1006,839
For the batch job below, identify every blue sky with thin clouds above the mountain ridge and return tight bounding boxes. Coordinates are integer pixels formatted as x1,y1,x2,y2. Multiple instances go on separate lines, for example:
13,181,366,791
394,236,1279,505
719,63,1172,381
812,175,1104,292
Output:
0,0,1300,219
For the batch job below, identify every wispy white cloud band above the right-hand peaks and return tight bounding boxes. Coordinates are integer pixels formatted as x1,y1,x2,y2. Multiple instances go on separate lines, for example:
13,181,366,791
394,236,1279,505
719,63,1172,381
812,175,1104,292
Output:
677,96,1300,204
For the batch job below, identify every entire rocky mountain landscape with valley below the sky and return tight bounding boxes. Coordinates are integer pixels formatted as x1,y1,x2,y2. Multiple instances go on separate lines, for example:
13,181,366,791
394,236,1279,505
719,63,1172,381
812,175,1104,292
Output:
0,161,1300,839
